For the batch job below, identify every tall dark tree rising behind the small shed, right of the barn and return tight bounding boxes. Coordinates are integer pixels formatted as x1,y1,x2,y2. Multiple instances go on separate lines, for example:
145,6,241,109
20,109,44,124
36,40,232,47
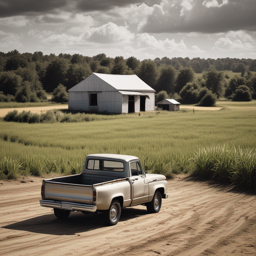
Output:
155,66,176,94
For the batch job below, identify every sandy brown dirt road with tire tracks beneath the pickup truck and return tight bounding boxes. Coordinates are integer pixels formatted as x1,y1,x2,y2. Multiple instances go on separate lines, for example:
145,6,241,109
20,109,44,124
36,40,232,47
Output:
0,176,256,256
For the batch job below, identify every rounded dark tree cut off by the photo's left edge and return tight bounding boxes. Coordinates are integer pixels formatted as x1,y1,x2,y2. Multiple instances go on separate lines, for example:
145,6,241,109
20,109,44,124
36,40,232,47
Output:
0,71,22,95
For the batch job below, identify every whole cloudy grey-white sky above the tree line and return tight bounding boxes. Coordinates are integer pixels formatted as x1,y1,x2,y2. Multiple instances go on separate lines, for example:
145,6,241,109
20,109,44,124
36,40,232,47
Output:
0,0,256,60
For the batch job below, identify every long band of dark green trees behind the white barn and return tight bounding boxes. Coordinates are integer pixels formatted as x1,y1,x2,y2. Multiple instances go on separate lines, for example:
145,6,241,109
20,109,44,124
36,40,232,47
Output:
0,50,256,105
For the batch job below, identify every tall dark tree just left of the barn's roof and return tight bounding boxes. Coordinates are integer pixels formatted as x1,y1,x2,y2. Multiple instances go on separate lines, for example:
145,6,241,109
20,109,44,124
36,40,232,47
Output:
42,58,69,92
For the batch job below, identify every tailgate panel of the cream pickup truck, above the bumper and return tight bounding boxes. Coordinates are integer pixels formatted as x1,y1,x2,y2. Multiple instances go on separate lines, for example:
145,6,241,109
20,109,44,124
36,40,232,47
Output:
44,181,93,204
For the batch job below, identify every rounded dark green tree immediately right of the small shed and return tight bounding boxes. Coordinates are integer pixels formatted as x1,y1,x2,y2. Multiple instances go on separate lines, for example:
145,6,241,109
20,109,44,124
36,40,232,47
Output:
180,82,200,104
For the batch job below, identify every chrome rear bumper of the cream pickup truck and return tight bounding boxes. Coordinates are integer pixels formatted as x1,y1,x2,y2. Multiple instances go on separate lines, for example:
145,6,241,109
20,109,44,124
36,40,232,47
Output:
40,200,97,212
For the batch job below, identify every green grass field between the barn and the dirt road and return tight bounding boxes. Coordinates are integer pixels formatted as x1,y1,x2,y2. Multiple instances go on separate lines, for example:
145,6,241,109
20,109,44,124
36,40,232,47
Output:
0,101,256,184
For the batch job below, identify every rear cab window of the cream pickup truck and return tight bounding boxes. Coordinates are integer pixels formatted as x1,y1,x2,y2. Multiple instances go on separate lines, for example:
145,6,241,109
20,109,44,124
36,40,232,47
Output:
87,159,124,172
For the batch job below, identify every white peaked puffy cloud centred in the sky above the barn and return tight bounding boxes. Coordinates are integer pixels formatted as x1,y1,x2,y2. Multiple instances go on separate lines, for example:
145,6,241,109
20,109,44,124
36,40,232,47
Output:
84,22,134,44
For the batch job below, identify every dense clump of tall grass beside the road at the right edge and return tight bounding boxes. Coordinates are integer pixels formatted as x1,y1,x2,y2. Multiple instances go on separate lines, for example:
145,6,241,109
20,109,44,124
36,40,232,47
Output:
190,146,256,189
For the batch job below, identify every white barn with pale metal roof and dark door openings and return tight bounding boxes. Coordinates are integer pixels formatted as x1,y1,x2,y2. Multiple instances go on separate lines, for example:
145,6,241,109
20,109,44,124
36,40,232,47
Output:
68,73,155,114
